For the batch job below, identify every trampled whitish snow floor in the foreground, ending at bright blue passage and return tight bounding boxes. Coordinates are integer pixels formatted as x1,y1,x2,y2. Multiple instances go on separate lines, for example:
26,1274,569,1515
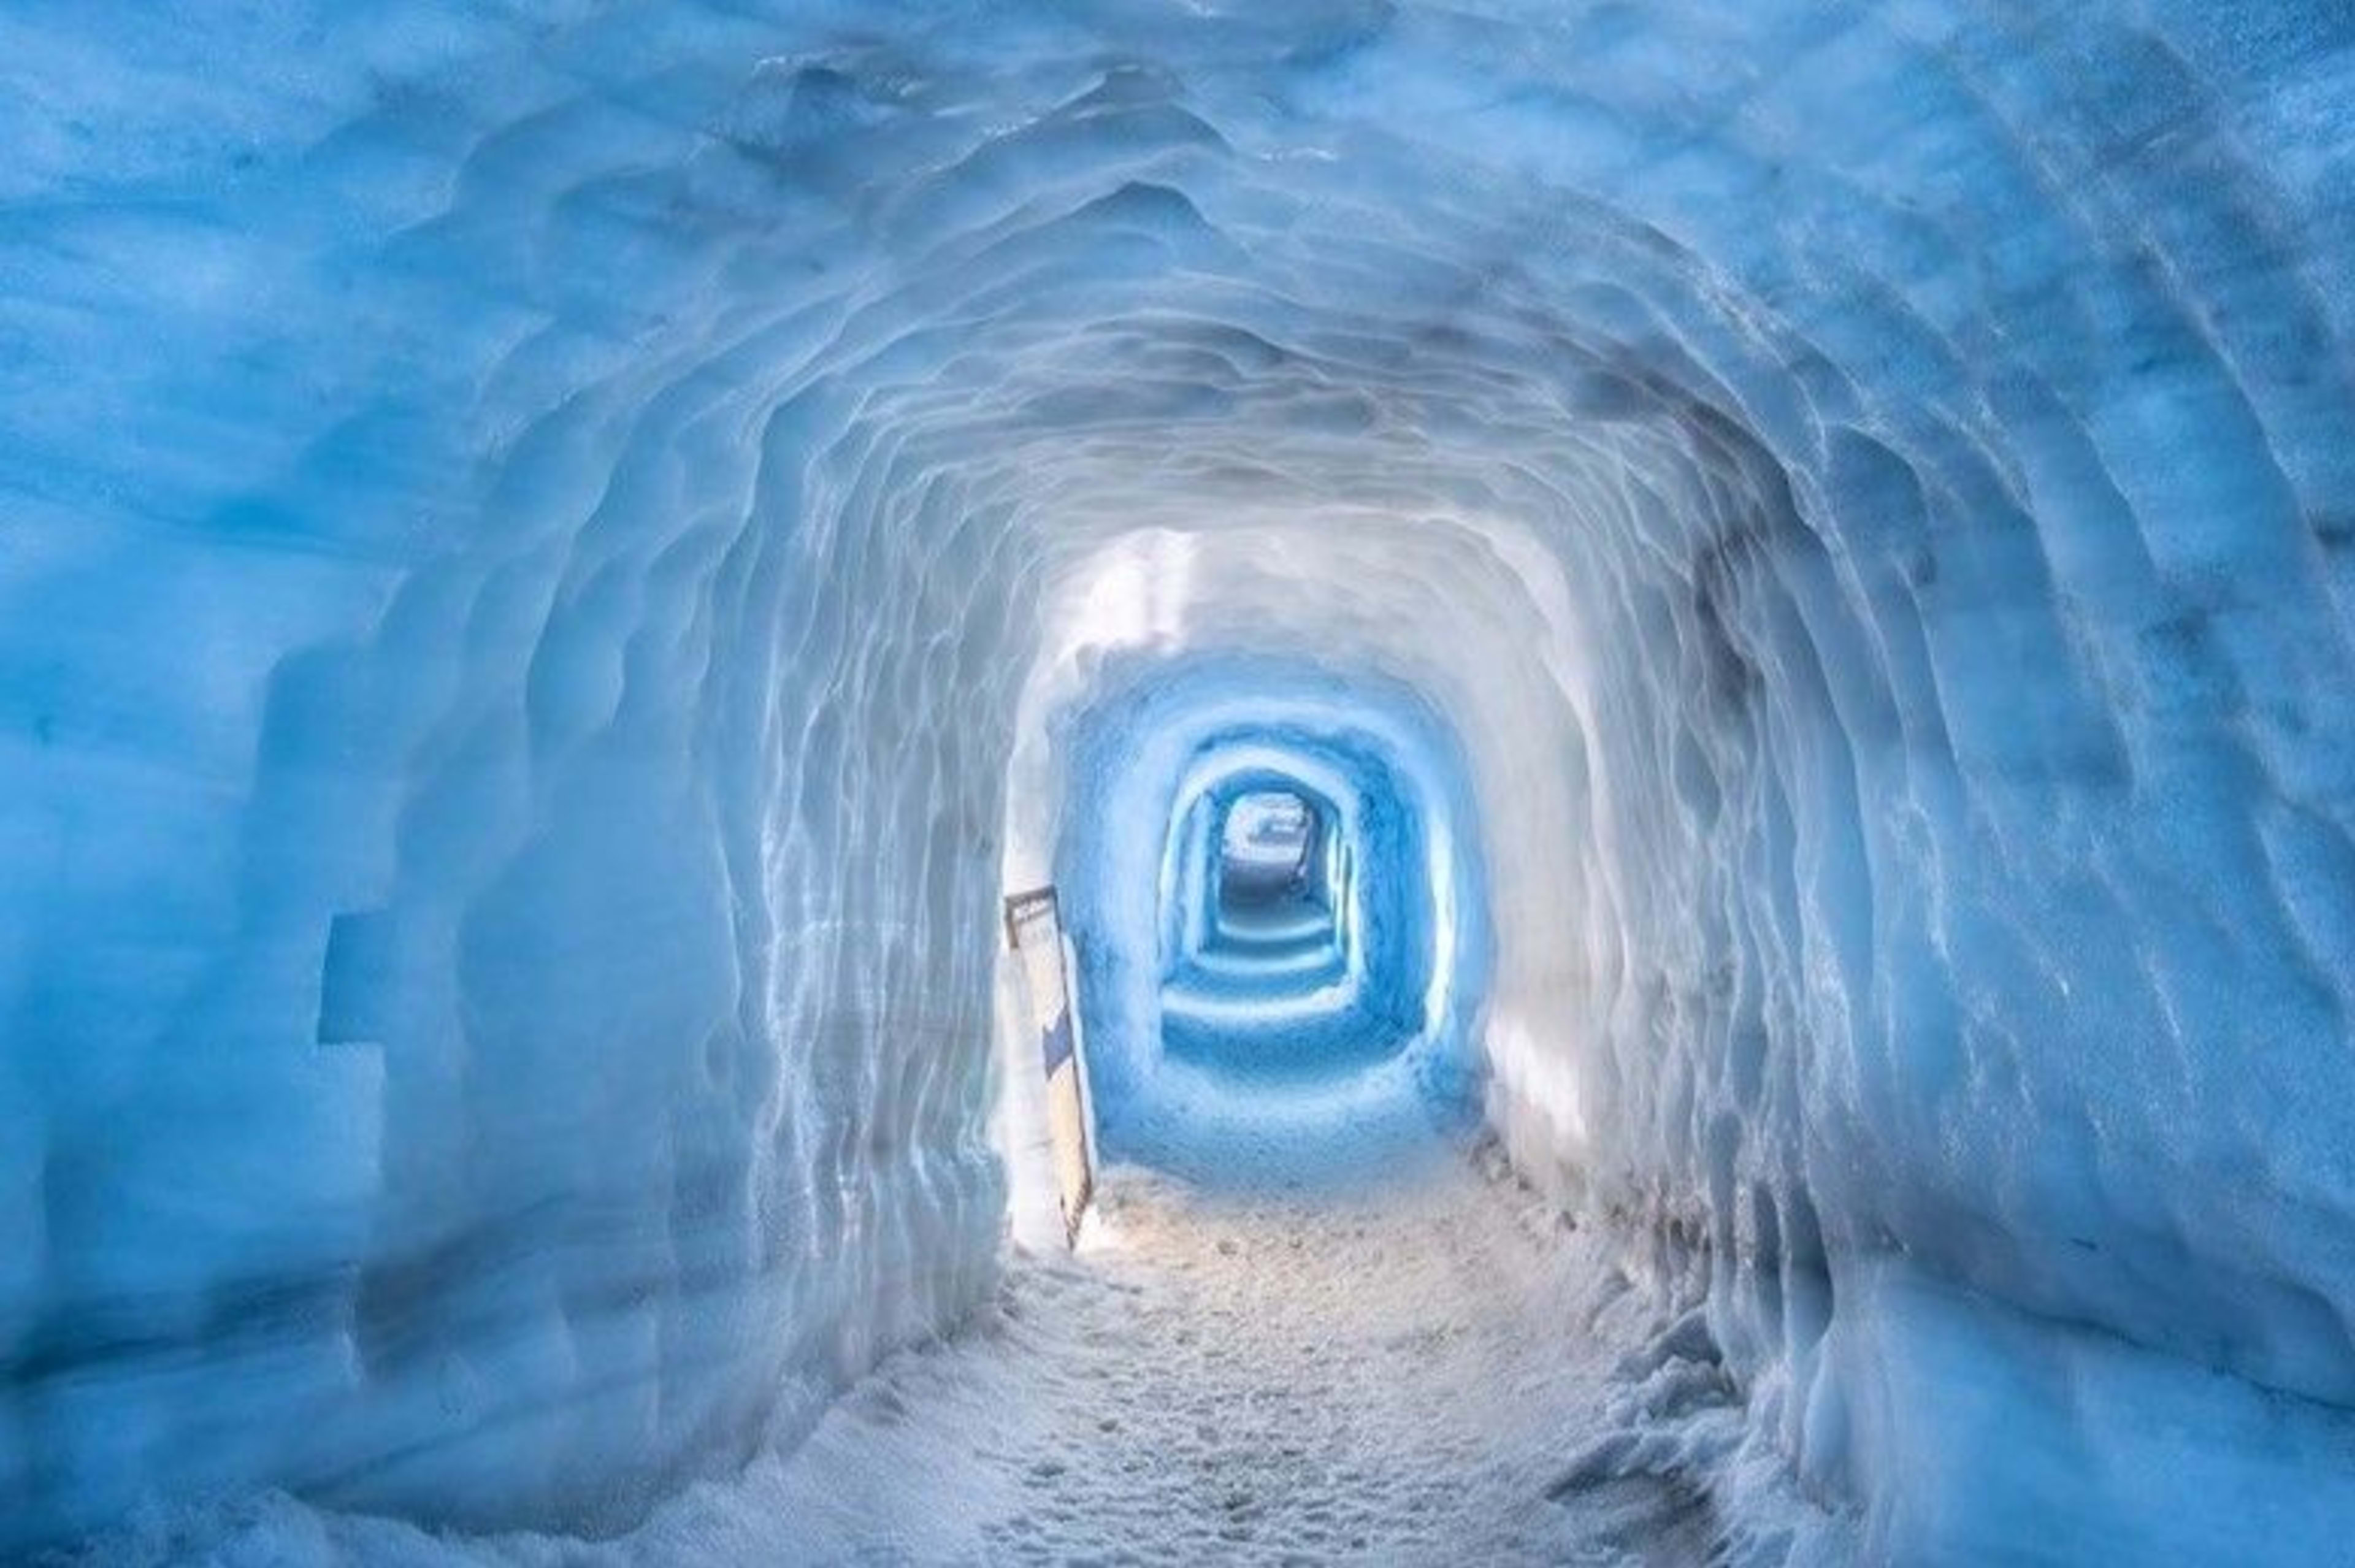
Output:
64,1149,1771,1568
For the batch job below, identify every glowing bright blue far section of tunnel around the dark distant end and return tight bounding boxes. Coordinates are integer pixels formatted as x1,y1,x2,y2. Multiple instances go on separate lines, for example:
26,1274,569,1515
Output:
1055,654,1488,1184
